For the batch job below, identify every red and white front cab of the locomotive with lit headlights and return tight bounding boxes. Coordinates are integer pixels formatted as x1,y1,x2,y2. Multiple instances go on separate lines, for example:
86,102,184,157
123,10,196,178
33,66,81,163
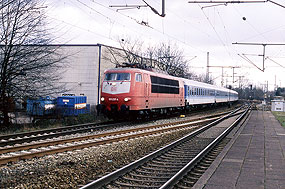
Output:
99,68,144,117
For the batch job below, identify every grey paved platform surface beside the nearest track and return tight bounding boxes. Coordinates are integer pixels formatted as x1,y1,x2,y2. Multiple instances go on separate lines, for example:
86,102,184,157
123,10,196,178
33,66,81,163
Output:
194,110,285,189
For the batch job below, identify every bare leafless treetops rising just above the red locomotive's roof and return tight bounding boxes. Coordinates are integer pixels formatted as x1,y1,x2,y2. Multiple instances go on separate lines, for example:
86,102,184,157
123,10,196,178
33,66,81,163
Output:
103,38,194,78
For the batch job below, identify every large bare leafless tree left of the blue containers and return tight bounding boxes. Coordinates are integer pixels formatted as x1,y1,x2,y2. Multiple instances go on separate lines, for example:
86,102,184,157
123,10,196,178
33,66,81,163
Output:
0,0,63,126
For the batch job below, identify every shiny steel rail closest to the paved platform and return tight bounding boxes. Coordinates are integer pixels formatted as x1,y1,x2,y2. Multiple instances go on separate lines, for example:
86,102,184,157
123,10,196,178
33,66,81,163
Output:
160,107,251,189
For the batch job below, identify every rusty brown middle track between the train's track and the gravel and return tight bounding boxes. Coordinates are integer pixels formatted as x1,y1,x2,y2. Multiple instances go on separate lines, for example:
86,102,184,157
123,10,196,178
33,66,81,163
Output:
0,109,242,164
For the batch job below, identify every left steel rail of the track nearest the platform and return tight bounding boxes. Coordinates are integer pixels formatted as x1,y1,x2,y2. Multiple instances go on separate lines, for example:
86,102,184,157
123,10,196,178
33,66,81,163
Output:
78,108,241,189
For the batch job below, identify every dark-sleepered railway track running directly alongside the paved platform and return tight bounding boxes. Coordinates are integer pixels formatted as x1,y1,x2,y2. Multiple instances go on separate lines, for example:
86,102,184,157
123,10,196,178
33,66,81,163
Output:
79,105,249,189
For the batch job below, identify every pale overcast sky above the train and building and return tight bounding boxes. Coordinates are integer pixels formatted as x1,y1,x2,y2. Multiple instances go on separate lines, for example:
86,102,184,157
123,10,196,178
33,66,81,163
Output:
47,0,285,90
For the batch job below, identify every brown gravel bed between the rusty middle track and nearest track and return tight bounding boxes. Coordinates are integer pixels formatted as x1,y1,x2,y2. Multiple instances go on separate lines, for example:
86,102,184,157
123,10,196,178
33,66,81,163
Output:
0,128,197,188
